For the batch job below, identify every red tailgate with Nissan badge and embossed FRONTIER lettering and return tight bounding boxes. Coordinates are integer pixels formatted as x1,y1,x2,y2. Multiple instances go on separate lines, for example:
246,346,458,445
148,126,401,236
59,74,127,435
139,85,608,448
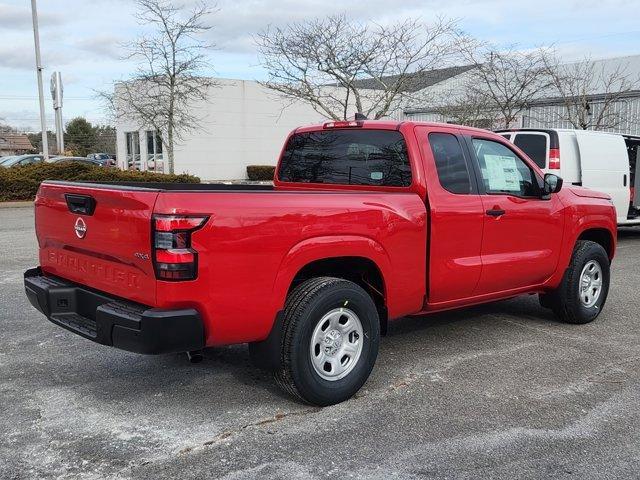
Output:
35,182,158,306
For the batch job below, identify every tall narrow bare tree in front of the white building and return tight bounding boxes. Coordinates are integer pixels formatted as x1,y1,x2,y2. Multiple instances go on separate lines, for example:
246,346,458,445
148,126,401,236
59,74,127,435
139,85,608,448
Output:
100,0,215,173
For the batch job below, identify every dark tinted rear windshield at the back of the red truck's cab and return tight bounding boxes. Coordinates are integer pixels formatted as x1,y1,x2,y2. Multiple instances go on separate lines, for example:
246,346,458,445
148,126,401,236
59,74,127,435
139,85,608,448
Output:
278,130,411,187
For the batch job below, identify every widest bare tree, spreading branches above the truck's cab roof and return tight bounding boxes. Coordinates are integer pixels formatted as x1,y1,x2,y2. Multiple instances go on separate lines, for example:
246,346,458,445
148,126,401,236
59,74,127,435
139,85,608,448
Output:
255,14,457,120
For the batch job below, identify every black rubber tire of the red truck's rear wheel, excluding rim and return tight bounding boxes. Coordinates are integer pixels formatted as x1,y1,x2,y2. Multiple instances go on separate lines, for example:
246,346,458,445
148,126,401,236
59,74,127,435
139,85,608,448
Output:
274,277,380,406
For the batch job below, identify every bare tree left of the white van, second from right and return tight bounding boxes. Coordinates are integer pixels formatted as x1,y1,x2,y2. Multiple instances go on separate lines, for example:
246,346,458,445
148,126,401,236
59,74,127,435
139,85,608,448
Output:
463,42,550,128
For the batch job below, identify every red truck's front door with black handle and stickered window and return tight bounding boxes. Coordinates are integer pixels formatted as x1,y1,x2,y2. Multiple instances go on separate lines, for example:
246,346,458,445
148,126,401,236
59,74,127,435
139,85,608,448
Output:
467,136,564,295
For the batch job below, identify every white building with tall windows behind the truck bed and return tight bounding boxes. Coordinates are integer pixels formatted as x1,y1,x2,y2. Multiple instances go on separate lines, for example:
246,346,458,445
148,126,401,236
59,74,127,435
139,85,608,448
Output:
116,79,323,180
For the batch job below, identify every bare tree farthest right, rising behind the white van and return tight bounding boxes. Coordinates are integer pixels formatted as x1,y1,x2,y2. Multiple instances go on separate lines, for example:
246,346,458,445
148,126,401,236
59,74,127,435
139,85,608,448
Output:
547,57,640,130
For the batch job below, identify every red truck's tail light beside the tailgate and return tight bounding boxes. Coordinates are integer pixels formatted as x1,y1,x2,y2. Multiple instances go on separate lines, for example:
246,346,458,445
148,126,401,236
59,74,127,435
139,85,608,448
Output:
153,215,209,280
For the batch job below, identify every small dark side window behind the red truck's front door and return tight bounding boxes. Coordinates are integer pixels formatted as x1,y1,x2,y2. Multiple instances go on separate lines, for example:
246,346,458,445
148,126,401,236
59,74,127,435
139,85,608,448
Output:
429,133,471,194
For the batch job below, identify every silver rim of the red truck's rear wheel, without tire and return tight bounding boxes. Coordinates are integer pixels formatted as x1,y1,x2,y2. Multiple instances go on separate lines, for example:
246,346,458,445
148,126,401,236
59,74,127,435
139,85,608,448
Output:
309,308,364,382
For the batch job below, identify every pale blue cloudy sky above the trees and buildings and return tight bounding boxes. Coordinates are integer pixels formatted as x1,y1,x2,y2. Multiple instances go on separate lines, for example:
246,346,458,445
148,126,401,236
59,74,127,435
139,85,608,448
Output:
0,0,640,129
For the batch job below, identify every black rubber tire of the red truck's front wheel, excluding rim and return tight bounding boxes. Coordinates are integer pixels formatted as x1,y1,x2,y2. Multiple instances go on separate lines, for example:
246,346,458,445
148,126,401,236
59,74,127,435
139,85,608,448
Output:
540,240,610,324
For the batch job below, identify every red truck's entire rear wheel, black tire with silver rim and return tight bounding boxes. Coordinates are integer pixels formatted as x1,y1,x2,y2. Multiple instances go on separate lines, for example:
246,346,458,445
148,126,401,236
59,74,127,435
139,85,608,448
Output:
275,277,380,406
